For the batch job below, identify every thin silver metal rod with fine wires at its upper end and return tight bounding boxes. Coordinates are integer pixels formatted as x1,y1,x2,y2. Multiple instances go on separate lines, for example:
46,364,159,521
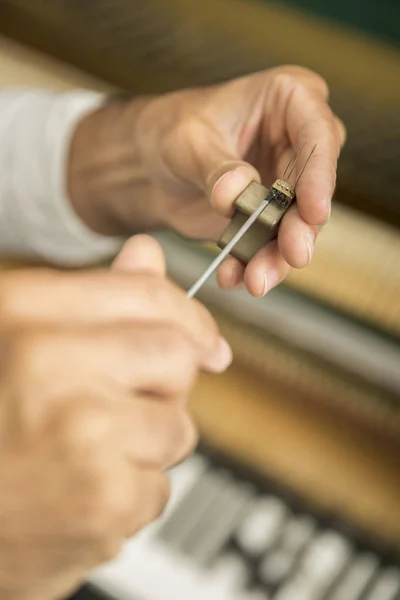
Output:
187,139,316,298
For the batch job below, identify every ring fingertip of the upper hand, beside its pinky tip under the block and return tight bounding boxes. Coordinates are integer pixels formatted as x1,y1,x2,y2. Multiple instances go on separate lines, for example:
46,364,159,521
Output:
244,241,290,298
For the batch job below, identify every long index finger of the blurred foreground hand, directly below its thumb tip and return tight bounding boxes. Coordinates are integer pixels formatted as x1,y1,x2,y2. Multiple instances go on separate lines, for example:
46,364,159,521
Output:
0,270,222,364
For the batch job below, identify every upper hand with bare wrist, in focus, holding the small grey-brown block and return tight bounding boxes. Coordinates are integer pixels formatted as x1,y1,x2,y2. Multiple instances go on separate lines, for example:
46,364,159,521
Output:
68,66,346,297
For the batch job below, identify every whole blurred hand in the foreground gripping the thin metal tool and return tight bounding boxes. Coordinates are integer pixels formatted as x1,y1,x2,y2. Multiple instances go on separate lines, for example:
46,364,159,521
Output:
0,236,231,600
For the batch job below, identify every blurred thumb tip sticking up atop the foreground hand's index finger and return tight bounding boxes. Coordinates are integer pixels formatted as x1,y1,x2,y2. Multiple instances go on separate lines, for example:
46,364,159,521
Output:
112,235,167,276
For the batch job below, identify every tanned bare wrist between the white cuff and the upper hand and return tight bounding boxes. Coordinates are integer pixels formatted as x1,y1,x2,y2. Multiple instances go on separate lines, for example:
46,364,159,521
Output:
67,97,162,236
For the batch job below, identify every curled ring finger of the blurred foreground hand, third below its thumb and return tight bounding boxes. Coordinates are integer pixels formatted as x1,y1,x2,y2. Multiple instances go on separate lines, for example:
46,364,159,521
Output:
70,395,198,469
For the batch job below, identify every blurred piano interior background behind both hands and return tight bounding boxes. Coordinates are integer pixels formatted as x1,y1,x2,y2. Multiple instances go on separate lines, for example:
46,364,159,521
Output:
0,0,400,600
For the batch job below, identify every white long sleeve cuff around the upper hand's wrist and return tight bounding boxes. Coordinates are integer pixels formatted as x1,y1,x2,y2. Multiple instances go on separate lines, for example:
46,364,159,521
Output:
0,89,122,267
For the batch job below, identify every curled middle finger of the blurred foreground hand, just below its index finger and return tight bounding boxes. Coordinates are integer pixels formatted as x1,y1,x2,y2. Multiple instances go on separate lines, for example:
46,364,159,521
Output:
18,325,231,426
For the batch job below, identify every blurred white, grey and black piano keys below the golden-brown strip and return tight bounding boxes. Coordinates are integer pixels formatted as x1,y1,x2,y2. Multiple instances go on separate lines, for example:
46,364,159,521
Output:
82,448,400,600
